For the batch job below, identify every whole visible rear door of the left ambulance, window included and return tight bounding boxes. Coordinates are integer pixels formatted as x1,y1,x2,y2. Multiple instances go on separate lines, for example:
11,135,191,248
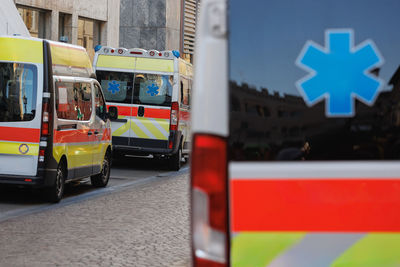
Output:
0,38,43,179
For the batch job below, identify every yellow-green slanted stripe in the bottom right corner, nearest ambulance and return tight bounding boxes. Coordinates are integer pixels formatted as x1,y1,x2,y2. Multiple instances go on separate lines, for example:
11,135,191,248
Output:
331,233,400,267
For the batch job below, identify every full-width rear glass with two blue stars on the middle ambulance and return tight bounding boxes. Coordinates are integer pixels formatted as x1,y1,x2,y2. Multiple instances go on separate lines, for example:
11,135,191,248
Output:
96,71,173,106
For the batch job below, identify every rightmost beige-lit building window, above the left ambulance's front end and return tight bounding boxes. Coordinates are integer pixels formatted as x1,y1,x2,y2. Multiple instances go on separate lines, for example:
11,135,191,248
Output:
78,18,101,60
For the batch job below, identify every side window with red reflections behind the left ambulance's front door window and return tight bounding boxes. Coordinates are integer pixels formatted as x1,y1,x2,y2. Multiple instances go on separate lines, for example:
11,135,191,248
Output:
56,82,92,121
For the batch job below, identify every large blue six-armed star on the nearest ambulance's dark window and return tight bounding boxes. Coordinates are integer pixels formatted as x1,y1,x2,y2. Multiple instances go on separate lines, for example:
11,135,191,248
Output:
296,29,384,117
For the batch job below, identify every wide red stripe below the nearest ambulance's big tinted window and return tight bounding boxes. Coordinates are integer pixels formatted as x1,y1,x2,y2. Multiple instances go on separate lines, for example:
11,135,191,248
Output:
231,178,400,232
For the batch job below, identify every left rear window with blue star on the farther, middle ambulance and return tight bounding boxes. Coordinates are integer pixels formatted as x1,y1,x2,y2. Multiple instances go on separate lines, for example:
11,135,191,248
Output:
96,71,133,104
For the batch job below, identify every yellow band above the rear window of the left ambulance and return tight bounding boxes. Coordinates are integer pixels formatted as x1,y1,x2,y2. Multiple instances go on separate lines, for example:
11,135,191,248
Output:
0,37,43,64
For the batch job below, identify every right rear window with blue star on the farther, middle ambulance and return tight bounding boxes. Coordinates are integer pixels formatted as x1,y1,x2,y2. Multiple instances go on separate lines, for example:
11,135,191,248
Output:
134,73,173,106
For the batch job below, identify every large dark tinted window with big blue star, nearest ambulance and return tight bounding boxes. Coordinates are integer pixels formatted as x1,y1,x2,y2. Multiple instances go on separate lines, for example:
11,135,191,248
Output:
229,0,400,161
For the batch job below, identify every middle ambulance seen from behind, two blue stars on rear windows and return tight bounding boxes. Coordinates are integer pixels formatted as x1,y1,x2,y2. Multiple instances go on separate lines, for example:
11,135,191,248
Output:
93,47,193,170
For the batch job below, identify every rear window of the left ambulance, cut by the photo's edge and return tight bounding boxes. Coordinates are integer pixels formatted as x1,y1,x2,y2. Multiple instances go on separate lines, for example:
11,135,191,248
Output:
0,63,37,122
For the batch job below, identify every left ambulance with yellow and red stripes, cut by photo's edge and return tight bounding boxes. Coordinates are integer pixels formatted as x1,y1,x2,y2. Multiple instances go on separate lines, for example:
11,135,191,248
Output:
0,36,112,202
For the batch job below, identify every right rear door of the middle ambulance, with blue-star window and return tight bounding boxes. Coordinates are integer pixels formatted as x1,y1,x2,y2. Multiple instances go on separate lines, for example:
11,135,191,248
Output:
129,57,178,149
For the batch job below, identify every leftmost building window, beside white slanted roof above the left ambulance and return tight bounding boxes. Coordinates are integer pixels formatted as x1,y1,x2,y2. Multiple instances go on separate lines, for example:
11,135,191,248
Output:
17,7,46,38
